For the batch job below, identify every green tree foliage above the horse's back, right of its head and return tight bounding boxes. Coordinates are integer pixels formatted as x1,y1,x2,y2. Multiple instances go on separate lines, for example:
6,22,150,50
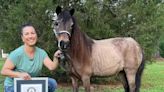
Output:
73,0,163,60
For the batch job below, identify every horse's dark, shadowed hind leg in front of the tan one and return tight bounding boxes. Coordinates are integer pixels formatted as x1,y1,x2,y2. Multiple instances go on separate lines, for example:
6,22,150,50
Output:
119,70,129,92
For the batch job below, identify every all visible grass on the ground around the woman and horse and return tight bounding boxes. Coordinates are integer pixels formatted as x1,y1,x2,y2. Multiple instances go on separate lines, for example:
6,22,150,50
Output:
0,59,164,92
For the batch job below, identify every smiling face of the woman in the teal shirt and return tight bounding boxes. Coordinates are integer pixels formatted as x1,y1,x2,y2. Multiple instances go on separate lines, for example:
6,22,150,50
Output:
22,26,37,46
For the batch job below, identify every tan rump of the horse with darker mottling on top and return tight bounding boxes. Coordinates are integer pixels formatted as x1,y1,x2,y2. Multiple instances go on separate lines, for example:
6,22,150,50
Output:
111,37,143,69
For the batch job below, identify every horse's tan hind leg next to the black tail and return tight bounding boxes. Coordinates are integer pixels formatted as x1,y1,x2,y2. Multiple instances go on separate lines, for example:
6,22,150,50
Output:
125,69,136,92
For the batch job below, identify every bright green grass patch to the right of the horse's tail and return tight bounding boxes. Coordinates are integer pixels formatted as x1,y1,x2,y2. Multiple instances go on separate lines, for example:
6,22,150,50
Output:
141,62,164,92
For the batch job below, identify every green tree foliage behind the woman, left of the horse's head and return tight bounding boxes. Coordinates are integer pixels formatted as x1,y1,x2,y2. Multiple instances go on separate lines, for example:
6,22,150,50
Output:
0,0,56,56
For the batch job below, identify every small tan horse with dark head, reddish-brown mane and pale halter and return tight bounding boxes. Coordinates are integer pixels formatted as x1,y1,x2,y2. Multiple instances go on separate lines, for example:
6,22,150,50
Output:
53,6,144,92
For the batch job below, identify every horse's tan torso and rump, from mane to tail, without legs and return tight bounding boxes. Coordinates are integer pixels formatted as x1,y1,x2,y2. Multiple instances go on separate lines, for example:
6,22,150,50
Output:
91,37,142,76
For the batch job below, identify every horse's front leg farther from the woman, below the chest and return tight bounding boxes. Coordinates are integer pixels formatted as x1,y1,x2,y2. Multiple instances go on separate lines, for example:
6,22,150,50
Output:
82,75,91,92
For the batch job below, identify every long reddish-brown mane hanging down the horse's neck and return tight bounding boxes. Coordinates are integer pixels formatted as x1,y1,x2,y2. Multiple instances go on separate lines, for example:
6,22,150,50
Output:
70,16,94,61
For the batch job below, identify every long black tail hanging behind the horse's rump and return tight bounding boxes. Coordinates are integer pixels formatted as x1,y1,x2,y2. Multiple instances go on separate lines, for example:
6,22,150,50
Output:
135,52,145,92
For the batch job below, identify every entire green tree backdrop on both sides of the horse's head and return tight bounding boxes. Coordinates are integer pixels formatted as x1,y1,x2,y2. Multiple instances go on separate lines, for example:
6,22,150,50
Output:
0,0,164,81
